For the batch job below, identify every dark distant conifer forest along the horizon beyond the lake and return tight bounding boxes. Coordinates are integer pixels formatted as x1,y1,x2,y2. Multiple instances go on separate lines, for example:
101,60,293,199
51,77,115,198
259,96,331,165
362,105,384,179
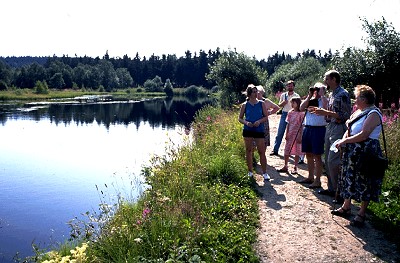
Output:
0,48,332,91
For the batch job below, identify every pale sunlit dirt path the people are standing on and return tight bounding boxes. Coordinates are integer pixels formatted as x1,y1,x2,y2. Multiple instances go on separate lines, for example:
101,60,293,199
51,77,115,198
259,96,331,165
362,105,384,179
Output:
256,115,400,263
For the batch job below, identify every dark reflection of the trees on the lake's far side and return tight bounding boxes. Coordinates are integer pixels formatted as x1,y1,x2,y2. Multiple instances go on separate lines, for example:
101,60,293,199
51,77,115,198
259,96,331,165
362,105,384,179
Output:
0,99,211,128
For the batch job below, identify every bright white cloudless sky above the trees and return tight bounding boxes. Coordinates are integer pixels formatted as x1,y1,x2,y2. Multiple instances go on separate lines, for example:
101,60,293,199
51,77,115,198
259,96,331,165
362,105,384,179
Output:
0,0,400,60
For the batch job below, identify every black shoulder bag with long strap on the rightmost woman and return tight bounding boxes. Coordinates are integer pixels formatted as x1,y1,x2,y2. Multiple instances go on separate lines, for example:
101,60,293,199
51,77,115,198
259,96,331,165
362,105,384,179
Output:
349,111,389,179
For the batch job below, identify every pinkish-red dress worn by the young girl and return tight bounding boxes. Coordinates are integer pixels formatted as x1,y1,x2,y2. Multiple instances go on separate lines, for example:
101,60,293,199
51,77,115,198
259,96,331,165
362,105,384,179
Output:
285,110,304,155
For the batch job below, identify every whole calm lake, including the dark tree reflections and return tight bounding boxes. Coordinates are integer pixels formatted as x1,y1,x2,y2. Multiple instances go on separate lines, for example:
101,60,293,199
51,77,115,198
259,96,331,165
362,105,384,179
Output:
0,100,211,262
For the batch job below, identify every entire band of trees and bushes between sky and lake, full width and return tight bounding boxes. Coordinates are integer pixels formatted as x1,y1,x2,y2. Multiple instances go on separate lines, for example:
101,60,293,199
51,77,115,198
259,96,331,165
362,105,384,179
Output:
0,18,400,107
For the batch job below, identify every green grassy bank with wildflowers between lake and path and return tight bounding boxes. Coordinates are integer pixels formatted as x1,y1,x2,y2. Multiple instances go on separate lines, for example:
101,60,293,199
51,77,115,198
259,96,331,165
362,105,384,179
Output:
37,107,259,262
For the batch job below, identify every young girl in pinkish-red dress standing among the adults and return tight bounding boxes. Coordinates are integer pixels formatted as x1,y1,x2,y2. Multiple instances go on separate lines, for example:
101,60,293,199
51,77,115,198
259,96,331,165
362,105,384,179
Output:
278,97,304,174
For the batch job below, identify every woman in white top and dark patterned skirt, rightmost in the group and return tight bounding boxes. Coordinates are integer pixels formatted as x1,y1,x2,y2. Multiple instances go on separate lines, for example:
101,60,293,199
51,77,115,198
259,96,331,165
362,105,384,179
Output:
331,85,382,226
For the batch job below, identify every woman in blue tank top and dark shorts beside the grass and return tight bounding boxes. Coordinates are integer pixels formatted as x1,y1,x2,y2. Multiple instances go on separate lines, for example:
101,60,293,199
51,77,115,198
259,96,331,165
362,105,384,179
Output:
239,84,270,180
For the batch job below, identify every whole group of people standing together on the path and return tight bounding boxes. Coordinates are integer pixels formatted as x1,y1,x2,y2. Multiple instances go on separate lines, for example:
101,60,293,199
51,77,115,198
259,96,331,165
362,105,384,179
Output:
239,70,382,226
